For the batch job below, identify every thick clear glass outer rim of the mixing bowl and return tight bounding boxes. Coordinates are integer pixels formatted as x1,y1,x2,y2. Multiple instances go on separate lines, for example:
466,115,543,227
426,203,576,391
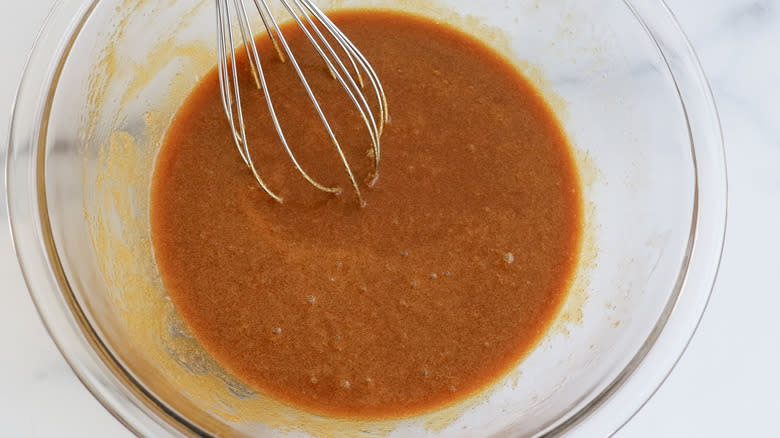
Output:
5,0,728,437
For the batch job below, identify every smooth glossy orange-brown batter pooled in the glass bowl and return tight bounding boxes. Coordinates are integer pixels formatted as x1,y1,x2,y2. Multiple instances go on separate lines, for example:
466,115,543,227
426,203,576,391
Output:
151,11,582,418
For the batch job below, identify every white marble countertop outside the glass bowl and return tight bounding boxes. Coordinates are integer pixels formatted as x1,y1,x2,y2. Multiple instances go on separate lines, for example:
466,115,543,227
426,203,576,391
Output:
0,0,780,438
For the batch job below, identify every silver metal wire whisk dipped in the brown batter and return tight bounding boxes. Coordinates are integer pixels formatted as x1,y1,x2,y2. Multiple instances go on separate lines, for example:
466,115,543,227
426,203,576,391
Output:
216,0,388,205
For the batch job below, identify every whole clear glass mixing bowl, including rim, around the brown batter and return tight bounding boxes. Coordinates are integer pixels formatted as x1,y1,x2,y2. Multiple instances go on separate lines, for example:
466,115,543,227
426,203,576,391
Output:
7,0,726,437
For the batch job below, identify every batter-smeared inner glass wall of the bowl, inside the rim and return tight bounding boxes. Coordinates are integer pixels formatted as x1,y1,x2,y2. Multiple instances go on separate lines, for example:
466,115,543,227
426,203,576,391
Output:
39,0,696,437
